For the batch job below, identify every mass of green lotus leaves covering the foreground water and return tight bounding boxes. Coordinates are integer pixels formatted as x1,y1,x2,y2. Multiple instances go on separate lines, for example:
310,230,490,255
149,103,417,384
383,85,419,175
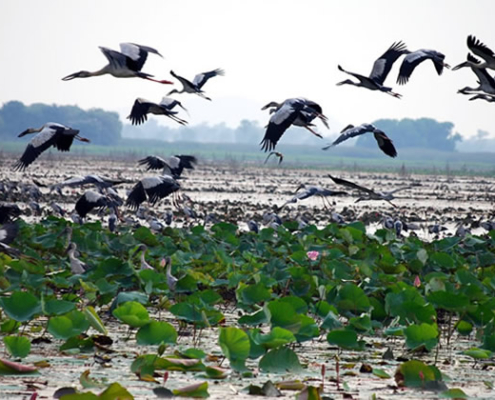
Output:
0,217,495,398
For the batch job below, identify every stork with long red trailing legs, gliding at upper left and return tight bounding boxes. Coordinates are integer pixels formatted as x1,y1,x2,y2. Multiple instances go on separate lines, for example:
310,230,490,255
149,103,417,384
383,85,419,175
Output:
62,43,173,85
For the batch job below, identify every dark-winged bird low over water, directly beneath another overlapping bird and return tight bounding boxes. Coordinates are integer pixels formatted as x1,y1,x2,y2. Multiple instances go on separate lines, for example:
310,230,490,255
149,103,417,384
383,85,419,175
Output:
125,175,180,209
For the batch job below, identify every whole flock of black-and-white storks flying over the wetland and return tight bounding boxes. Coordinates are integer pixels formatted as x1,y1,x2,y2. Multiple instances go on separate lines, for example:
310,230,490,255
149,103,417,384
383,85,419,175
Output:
0,35,495,256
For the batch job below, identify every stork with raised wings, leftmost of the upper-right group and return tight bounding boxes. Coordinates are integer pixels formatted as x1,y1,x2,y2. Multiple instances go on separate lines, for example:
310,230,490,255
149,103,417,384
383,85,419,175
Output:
337,42,407,99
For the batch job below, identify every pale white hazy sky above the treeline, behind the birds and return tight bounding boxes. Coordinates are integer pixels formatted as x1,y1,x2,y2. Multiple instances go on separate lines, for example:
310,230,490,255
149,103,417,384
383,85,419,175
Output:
0,0,495,137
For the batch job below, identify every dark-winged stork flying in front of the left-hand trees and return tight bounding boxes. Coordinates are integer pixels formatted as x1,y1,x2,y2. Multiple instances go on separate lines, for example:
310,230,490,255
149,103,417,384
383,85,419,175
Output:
14,122,90,171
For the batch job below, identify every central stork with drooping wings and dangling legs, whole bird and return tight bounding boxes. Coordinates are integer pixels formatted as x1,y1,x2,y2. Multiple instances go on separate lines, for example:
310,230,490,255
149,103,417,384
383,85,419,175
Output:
260,97,328,152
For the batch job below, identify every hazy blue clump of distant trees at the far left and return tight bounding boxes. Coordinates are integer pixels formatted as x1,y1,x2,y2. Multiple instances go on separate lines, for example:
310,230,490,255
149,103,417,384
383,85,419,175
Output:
0,101,122,145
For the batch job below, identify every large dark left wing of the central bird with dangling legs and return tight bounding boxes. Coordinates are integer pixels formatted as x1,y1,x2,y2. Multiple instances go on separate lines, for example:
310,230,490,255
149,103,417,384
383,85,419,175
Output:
260,101,304,151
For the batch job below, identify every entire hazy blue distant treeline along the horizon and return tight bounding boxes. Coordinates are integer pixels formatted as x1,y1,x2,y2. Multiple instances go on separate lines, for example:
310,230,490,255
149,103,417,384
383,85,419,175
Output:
0,101,462,151
